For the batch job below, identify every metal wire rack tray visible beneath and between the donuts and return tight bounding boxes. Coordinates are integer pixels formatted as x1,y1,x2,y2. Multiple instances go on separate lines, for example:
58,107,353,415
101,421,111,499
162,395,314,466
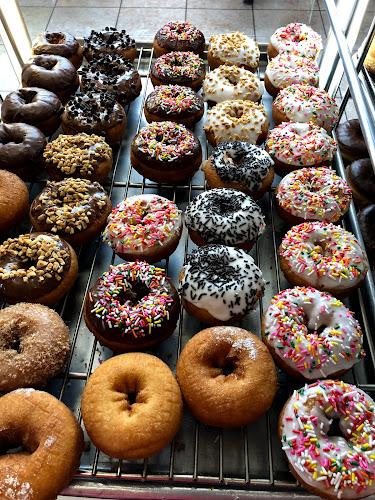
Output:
2,43,375,498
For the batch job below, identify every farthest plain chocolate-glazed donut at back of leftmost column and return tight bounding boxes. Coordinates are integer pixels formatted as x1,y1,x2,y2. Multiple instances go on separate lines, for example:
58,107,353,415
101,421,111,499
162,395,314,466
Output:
31,31,83,69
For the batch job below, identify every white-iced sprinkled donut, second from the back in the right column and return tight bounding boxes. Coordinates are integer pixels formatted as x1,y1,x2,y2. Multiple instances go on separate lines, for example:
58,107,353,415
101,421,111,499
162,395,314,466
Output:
264,52,319,97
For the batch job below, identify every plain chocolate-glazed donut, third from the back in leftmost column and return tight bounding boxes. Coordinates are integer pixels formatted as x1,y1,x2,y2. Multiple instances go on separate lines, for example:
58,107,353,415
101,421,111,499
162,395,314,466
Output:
1,87,63,135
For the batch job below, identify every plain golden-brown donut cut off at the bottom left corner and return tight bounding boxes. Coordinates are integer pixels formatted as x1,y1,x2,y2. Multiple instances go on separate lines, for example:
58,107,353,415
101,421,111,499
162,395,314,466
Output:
0,389,84,500
